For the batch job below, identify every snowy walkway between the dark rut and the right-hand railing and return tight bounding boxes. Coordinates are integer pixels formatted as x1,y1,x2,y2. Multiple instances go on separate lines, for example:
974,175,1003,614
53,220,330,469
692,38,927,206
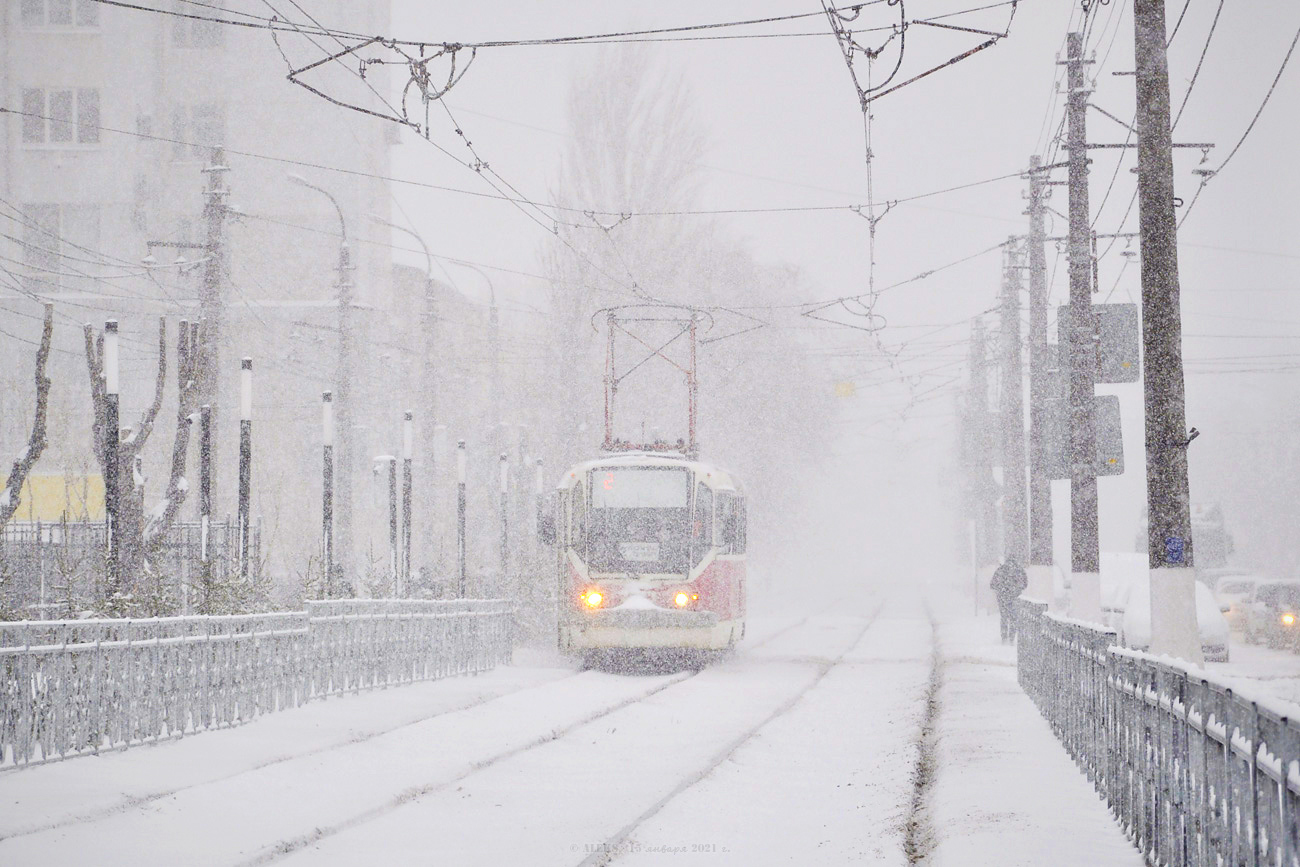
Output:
926,610,1143,867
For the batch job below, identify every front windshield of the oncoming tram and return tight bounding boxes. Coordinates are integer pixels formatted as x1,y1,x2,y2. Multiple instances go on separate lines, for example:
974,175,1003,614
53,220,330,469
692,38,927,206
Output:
586,467,690,575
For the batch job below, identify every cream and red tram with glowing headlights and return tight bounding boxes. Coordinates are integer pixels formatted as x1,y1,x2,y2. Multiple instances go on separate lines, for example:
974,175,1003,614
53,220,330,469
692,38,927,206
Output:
549,452,745,655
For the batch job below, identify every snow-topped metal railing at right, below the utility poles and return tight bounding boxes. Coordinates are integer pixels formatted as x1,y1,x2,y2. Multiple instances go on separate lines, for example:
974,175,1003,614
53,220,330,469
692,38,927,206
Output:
1017,599,1300,867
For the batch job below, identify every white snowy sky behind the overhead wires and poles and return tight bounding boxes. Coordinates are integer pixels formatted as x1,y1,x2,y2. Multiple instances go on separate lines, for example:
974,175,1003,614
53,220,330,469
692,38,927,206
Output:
361,0,1300,571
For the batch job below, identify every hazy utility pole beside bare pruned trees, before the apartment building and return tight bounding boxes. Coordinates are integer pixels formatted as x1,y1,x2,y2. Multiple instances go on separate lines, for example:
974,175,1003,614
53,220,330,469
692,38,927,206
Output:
198,147,230,512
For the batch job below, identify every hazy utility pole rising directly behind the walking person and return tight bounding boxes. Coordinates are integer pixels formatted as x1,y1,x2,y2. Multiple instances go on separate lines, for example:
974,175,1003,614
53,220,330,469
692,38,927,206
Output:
1001,238,1028,563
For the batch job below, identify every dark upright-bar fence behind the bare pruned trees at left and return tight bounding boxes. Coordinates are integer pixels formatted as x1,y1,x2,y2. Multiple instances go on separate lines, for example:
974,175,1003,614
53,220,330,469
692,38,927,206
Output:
0,517,261,617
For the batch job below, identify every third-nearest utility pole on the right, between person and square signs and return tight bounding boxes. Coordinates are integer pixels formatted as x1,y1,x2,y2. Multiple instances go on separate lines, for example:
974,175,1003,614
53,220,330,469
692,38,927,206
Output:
1027,156,1054,602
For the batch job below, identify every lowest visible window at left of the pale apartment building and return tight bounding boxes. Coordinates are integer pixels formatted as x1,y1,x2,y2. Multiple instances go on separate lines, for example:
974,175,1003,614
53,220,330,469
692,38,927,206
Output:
22,204,99,291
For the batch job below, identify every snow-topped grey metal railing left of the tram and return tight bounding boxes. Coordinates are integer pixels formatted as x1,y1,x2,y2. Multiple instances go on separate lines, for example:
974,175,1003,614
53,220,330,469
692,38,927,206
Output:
0,599,511,767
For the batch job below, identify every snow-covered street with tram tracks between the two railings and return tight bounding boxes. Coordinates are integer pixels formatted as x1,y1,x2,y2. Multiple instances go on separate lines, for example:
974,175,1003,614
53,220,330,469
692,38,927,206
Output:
0,594,1138,864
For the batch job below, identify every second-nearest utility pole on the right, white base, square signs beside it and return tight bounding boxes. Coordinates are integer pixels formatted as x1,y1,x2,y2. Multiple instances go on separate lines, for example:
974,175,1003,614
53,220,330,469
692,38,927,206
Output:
1062,32,1101,621
